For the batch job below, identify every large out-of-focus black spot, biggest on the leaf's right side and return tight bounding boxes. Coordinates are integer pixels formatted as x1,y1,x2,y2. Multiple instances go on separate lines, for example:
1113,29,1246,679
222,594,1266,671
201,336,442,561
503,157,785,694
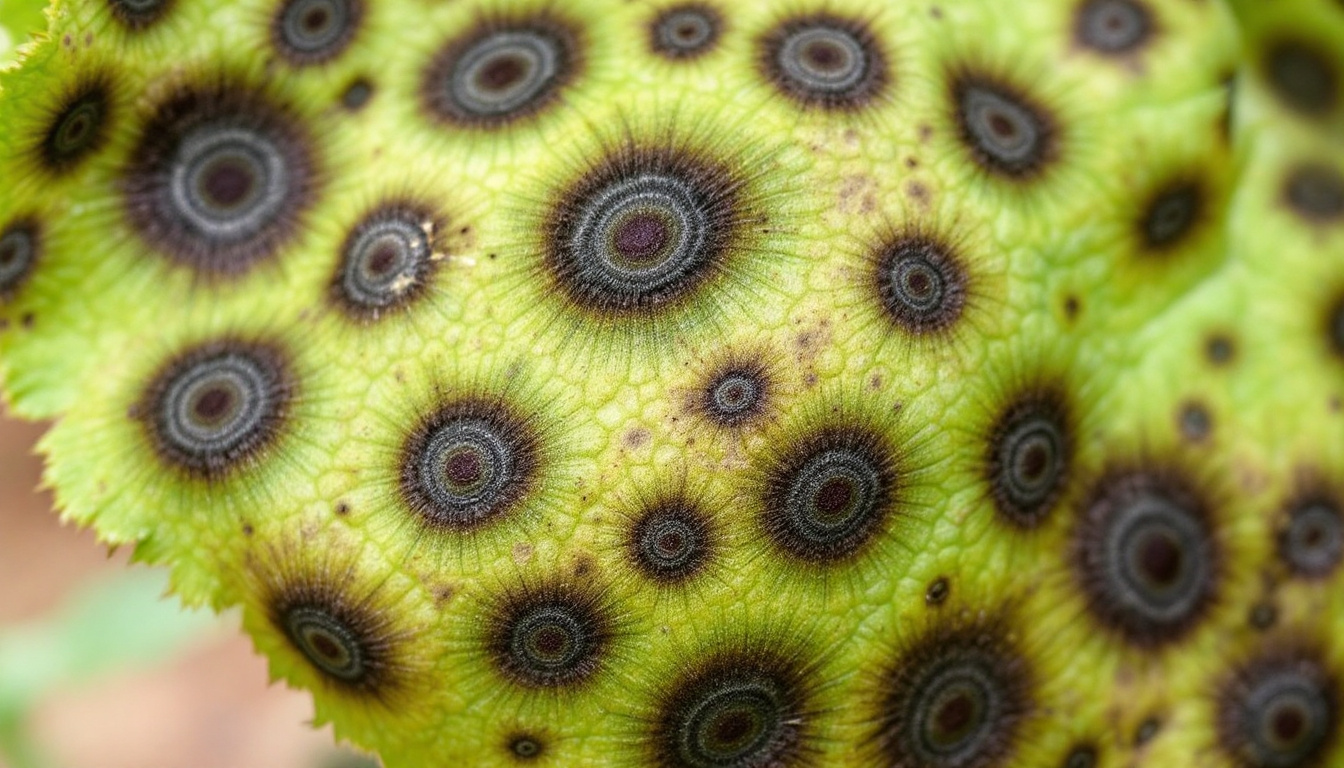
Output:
1073,468,1220,647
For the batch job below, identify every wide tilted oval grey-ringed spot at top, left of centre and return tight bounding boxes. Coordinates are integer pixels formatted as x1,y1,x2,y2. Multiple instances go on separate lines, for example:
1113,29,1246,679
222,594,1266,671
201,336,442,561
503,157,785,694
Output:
421,16,582,128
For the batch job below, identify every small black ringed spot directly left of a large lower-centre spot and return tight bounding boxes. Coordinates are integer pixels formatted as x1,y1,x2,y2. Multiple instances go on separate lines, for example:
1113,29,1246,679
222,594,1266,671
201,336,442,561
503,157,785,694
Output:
629,500,712,584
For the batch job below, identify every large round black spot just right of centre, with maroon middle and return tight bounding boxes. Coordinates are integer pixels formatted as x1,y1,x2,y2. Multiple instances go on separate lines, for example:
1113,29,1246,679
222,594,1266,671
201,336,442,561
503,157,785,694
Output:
761,426,902,565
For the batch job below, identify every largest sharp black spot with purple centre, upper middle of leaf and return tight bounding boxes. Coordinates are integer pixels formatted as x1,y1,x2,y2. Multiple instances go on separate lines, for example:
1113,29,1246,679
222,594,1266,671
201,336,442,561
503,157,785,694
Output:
543,148,743,317
